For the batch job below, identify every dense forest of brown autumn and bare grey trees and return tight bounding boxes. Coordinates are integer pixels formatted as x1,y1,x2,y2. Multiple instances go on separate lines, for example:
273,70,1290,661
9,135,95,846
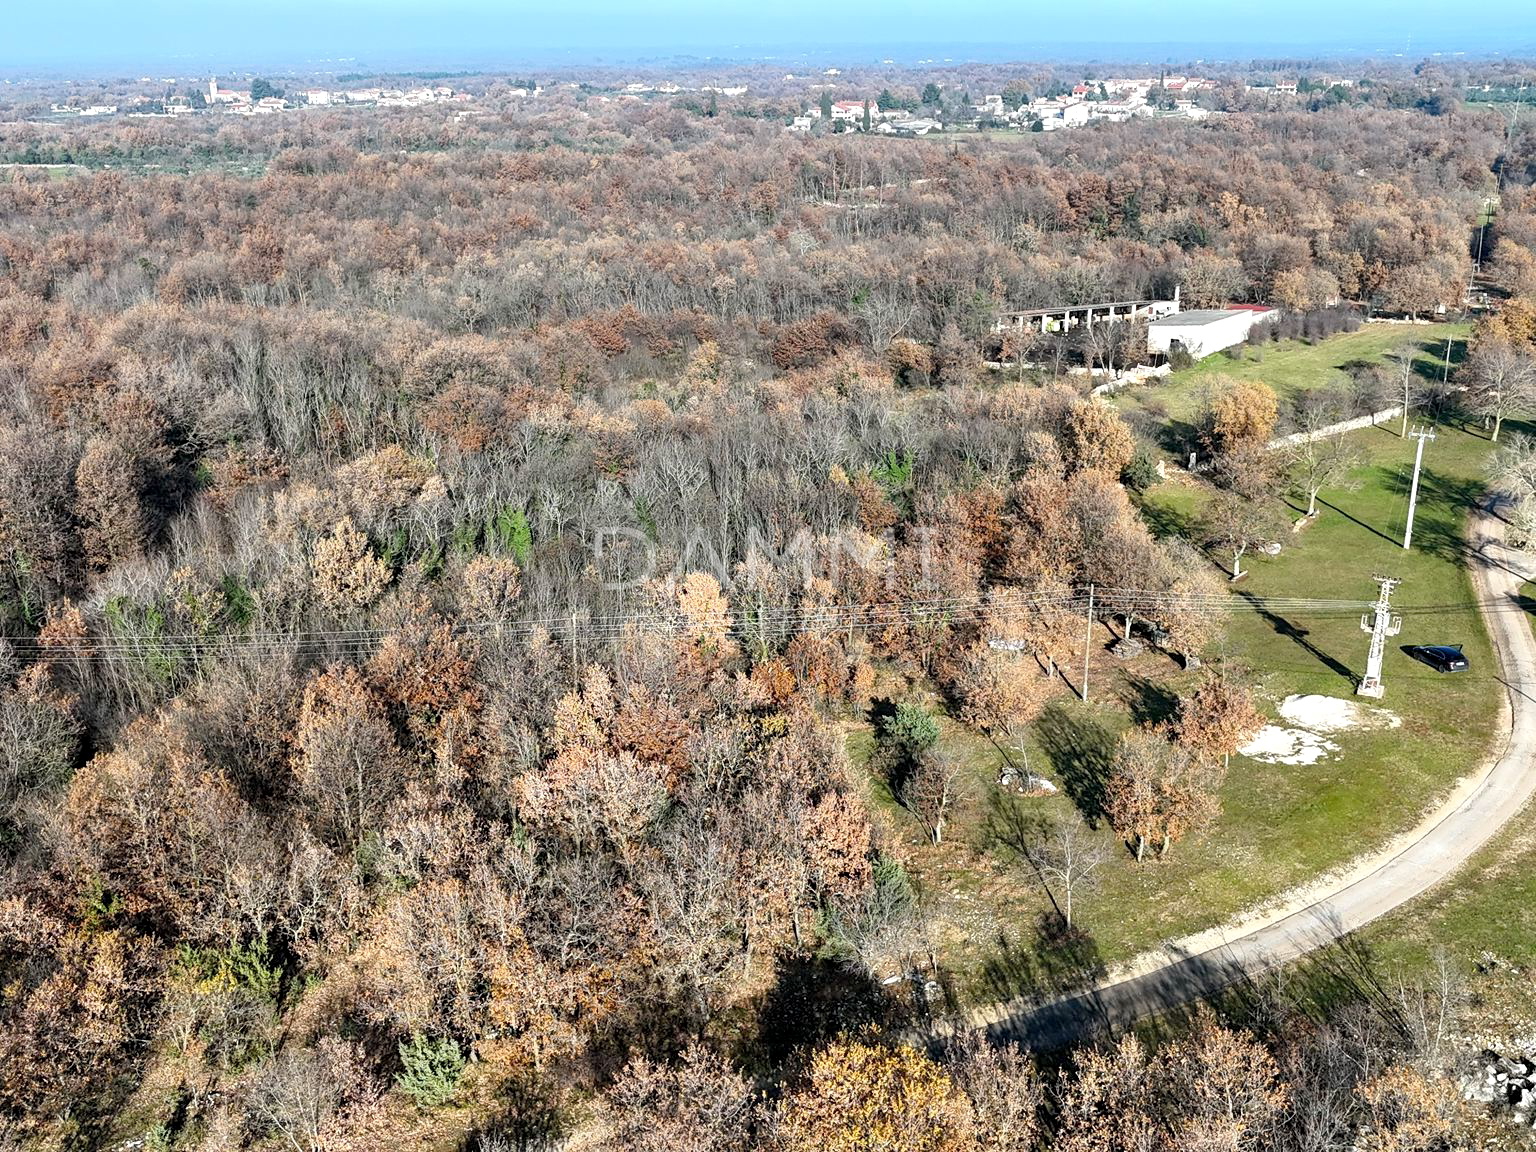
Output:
0,61,1536,1152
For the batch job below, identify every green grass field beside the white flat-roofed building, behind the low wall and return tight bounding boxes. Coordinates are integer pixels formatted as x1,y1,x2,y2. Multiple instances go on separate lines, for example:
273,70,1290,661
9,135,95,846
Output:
1115,324,1471,422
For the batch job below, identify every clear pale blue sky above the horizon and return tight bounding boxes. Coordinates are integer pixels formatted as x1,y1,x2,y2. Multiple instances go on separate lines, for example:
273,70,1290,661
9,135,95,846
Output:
0,0,1536,71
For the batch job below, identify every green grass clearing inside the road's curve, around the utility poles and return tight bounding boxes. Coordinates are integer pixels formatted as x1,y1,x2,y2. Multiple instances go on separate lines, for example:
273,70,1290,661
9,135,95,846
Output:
849,356,1499,1001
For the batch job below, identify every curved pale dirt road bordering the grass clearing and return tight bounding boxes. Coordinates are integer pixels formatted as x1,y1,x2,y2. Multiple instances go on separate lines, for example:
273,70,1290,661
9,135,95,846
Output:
971,500,1536,1049
